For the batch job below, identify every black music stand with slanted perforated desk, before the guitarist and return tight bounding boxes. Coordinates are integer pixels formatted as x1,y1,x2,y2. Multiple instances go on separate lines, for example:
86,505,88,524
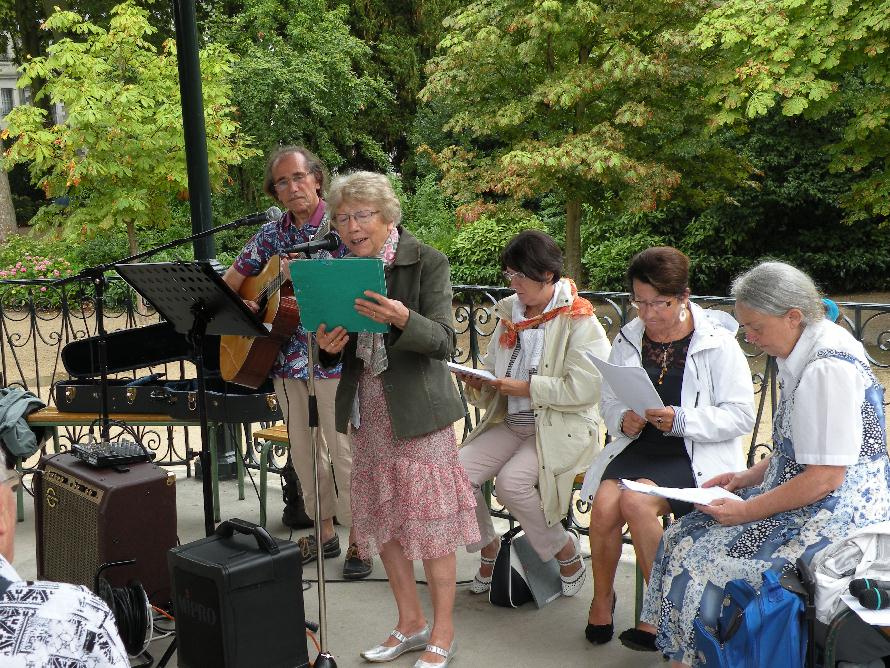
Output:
115,261,269,536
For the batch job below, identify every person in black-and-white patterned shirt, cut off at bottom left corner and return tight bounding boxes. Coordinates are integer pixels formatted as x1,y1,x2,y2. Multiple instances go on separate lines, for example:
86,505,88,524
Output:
0,446,130,668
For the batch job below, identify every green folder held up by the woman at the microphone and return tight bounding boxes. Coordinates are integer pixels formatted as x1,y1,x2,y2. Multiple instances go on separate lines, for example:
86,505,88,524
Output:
290,257,389,334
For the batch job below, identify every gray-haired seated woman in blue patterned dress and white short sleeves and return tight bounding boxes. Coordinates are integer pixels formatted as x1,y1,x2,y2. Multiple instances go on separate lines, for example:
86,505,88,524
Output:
624,262,890,665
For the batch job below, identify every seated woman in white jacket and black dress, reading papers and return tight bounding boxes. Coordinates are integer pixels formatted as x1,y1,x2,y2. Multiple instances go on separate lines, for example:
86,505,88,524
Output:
581,246,754,650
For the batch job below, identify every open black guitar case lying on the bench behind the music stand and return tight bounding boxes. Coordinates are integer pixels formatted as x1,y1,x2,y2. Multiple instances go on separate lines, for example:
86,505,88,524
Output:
54,322,281,423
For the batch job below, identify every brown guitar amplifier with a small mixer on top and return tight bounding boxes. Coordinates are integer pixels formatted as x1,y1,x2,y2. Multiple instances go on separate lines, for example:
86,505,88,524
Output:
34,453,176,608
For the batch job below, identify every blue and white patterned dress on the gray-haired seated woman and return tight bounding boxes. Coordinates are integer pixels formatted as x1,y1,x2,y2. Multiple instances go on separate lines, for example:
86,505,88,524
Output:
641,336,890,665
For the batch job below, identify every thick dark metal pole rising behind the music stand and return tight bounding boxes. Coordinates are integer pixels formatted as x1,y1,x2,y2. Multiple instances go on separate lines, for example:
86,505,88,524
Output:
173,0,216,260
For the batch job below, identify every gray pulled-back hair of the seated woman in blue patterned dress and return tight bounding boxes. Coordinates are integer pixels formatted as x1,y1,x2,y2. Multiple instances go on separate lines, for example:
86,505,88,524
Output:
731,261,825,325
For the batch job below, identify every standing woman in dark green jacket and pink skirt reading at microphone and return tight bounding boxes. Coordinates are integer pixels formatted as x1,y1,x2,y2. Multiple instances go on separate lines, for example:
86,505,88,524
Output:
317,172,479,668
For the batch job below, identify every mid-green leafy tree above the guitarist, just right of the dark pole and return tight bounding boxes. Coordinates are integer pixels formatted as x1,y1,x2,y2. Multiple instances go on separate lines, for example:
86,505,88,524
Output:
208,0,391,206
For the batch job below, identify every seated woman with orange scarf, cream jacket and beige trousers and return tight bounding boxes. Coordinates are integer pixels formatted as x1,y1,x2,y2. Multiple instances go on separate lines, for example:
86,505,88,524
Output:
460,230,609,596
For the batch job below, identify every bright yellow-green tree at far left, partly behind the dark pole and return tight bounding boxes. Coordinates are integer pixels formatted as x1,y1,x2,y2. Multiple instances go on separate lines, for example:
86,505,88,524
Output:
3,2,255,251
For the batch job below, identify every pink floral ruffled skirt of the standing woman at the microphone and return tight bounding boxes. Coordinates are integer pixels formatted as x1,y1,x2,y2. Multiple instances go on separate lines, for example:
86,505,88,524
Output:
351,371,480,560
